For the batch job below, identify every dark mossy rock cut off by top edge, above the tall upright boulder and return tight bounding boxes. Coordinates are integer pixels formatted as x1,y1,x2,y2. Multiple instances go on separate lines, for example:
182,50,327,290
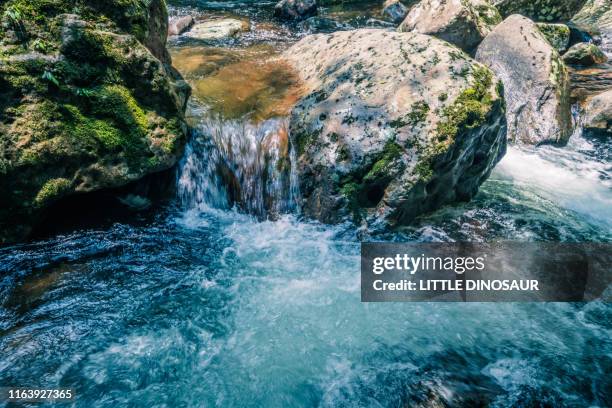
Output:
492,0,584,21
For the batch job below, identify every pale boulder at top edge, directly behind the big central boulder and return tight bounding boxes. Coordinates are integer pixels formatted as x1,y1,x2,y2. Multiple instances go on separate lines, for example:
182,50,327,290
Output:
399,0,501,51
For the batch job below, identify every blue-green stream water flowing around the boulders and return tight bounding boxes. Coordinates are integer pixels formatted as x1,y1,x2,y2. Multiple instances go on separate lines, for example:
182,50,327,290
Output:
0,3,612,407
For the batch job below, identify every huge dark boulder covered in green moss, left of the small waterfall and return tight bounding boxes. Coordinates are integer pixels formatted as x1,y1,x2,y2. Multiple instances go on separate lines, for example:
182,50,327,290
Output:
0,0,189,242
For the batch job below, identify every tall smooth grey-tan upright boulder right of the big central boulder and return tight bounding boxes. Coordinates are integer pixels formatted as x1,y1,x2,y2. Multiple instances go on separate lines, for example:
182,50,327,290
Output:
476,15,572,145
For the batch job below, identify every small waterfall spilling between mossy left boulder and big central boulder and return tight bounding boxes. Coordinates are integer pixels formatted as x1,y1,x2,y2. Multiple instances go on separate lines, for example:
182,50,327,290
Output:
178,108,299,219
